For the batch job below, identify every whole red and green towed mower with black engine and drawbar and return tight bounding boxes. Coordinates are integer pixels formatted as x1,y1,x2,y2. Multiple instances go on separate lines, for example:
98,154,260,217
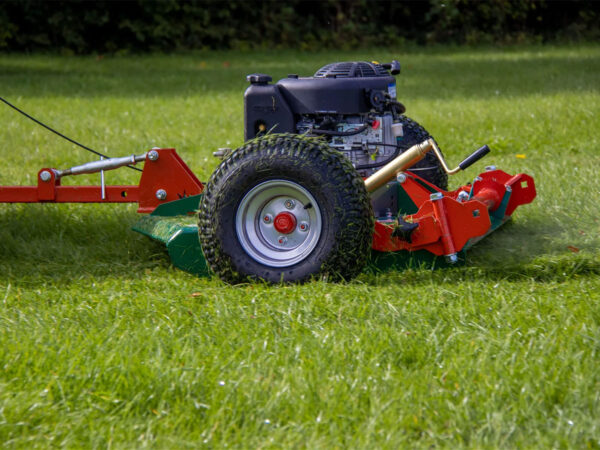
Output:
0,61,536,283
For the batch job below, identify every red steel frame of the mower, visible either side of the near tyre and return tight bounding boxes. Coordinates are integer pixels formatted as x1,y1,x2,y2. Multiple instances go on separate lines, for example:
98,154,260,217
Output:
0,148,536,256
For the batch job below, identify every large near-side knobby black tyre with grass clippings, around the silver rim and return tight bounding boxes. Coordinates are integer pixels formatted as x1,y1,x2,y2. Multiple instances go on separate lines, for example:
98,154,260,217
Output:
199,135,374,283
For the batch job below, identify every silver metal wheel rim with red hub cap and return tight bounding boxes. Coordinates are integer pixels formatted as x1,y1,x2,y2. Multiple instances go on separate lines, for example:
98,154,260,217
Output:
235,180,323,267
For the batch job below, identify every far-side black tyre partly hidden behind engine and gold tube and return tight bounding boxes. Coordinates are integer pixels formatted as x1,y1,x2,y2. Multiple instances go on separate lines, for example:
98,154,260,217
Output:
398,116,448,190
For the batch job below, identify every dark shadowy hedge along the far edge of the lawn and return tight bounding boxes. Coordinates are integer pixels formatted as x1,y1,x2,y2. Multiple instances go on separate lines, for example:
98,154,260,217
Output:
0,0,600,53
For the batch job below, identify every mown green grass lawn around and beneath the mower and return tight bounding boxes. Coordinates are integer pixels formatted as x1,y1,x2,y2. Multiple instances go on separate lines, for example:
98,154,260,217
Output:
0,45,600,448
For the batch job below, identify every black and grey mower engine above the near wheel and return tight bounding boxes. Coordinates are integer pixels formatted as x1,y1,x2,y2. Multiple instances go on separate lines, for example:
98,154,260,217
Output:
245,61,447,188
